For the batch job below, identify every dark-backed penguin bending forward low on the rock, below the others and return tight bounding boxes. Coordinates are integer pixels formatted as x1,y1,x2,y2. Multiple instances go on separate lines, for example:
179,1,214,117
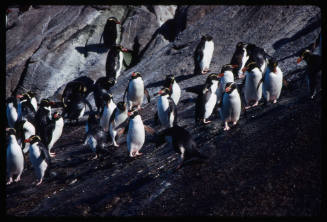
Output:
156,124,208,169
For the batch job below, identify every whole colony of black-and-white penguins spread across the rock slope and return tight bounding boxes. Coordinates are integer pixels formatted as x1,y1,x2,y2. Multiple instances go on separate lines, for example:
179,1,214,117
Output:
6,14,321,185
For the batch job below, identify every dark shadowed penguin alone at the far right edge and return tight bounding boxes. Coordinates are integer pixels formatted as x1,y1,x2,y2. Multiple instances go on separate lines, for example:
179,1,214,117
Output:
297,49,321,99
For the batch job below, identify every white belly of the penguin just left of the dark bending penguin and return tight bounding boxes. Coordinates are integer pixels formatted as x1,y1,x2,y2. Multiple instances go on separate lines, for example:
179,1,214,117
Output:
127,115,145,152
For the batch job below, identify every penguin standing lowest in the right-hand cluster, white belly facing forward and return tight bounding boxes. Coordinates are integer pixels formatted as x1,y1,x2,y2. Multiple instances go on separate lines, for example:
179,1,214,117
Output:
219,82,241,130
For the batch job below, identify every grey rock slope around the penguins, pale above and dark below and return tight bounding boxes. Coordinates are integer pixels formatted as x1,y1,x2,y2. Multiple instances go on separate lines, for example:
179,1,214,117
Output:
6,5,321,216
